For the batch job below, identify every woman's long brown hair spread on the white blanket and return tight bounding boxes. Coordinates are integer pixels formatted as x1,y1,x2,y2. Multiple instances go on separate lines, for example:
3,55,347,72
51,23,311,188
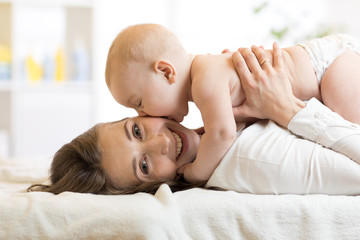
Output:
28,120,205,195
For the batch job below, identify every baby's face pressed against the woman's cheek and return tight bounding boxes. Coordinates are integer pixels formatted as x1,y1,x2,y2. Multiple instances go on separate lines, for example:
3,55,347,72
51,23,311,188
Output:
109,60,188,122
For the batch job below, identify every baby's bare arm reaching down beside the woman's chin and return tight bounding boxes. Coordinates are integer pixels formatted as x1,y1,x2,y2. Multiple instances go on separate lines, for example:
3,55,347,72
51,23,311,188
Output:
184,56,236,182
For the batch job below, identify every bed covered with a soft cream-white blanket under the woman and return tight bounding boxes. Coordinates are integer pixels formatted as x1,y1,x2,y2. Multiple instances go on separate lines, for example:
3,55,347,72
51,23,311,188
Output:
0,159,360,240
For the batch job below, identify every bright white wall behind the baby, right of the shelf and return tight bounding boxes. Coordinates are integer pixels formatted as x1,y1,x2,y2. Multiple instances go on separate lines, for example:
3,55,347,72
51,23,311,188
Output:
94,0,360,127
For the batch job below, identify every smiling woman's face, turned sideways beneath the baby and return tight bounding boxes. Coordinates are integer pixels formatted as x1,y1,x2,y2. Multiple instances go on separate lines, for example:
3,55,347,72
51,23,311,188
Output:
99,117,200,187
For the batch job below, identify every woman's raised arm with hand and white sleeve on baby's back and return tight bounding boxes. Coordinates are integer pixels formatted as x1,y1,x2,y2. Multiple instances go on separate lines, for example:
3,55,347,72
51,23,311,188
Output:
233,44,360,164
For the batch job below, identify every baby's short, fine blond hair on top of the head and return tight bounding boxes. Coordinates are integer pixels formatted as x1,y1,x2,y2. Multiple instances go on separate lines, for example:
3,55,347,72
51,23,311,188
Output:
105,24,186,86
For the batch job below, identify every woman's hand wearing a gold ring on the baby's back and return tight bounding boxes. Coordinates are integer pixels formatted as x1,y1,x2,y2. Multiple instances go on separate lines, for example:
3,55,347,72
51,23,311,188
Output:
233,43,305,127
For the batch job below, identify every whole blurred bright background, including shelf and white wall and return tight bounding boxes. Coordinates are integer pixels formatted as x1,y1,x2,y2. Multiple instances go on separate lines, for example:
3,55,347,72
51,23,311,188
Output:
0,0,360,159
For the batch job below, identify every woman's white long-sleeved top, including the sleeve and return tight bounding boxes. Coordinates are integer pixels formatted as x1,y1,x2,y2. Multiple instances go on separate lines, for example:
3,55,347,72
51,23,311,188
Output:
207,98,360,195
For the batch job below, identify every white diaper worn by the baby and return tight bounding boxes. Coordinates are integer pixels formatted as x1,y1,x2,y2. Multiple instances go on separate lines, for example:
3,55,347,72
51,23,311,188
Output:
298,34,360,83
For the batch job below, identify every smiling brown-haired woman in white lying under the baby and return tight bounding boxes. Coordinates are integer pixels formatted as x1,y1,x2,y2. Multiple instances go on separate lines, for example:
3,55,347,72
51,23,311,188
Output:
30,45,360,195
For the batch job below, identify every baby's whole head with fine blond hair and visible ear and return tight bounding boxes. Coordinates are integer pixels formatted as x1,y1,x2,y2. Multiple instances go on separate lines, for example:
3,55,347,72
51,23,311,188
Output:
105,24,189,122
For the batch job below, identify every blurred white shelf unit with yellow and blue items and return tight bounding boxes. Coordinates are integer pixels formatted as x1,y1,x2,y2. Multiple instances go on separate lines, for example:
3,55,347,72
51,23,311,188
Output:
0,0,95,158
